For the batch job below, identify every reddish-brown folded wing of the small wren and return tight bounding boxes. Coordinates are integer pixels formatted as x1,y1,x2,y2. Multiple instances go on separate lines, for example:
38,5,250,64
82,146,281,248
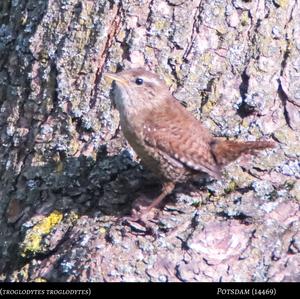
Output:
143,99,220,178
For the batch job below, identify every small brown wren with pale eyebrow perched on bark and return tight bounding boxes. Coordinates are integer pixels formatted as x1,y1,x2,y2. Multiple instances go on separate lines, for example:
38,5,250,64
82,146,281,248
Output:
105,68,274,218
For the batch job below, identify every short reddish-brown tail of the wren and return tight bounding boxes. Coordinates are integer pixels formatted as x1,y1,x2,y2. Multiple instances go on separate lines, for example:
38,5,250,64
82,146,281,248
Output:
211,139,275,167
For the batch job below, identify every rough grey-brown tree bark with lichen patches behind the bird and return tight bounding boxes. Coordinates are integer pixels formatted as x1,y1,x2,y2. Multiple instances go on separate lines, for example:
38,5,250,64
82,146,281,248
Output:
0,0,300,281
